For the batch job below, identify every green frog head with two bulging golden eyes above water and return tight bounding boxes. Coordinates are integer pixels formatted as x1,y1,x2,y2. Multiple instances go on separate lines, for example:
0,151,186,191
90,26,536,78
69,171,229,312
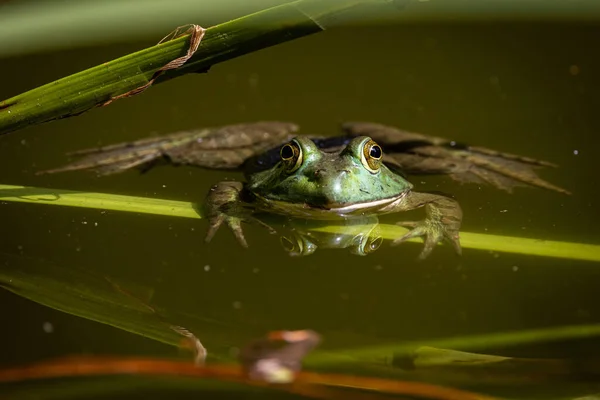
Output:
247,136,412,209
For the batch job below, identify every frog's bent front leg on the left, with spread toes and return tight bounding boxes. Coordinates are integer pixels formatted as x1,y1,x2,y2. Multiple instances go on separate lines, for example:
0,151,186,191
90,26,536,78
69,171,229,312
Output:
205,181,275,247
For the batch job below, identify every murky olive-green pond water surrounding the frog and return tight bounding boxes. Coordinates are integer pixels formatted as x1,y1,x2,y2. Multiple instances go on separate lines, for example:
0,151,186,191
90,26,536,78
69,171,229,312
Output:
0,19,600,398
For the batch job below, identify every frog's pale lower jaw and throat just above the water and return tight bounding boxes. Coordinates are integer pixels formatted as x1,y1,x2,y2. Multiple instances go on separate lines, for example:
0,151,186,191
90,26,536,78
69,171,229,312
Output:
255,191,409,219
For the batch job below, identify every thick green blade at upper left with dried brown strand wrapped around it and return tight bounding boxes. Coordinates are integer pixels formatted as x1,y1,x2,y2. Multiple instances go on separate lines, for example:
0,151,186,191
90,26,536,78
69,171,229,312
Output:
0,0,388,134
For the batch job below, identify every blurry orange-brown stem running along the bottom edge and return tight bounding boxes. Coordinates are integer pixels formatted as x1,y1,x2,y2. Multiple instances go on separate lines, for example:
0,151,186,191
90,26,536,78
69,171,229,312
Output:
0,356,494,400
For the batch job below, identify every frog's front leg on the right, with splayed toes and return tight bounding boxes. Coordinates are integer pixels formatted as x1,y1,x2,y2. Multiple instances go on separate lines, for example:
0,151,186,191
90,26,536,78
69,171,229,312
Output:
392,192,462,259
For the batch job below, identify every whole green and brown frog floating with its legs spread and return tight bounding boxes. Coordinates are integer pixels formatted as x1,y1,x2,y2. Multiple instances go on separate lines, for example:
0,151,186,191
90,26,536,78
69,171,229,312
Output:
48,121,568,258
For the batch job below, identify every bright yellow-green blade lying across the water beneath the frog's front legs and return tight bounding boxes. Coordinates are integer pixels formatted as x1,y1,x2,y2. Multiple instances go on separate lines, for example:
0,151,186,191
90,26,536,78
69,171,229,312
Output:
0,185,600,261
